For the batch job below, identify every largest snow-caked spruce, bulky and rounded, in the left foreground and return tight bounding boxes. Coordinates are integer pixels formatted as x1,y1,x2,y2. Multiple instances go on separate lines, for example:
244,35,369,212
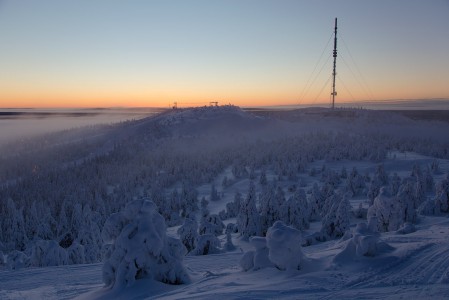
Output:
102,199,189,289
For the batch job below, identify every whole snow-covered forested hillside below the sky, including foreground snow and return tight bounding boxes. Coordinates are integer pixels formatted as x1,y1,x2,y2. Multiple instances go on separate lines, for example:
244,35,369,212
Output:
0,106,449,299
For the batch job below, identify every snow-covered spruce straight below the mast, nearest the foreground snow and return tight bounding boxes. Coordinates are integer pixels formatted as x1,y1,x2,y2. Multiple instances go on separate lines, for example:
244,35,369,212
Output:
321,193,351,239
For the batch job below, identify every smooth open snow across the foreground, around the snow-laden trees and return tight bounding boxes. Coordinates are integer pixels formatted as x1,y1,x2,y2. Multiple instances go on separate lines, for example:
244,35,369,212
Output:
0,217,449,299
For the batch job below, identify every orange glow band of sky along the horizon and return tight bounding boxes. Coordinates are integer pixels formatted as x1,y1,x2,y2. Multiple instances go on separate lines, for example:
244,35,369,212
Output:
0,86,447,108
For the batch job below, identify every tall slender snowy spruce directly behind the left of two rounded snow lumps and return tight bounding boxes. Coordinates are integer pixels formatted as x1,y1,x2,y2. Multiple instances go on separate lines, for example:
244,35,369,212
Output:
237,181,261,240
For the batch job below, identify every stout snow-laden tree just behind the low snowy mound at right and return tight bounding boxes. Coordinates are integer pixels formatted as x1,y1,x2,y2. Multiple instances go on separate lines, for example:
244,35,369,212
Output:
367,187,403,232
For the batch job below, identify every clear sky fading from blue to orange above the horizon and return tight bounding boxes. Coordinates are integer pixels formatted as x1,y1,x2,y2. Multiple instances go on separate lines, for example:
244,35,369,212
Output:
0,0,449,107
